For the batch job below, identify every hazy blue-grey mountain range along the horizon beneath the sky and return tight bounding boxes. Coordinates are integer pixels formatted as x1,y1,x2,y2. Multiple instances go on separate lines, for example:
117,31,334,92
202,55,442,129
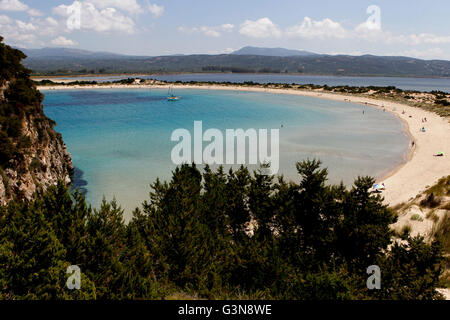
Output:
23,47,450,77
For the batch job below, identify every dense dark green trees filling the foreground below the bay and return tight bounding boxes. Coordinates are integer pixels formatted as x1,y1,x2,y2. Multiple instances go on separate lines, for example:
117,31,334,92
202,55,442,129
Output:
0,161,442,299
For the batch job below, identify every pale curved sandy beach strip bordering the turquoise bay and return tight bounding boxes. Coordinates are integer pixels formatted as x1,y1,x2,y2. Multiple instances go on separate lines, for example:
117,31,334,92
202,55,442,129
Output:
38,84,450,206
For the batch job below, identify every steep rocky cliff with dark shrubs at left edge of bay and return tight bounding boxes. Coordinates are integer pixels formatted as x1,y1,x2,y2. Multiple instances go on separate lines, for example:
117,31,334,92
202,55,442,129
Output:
0,37,73,205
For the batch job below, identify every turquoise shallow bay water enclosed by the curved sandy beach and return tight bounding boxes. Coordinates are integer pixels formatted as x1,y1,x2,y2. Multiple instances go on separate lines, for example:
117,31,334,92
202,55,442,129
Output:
44,89,410,218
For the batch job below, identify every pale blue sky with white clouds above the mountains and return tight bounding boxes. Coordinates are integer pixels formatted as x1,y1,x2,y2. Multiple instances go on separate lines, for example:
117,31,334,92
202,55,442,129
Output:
0,0,450,60
